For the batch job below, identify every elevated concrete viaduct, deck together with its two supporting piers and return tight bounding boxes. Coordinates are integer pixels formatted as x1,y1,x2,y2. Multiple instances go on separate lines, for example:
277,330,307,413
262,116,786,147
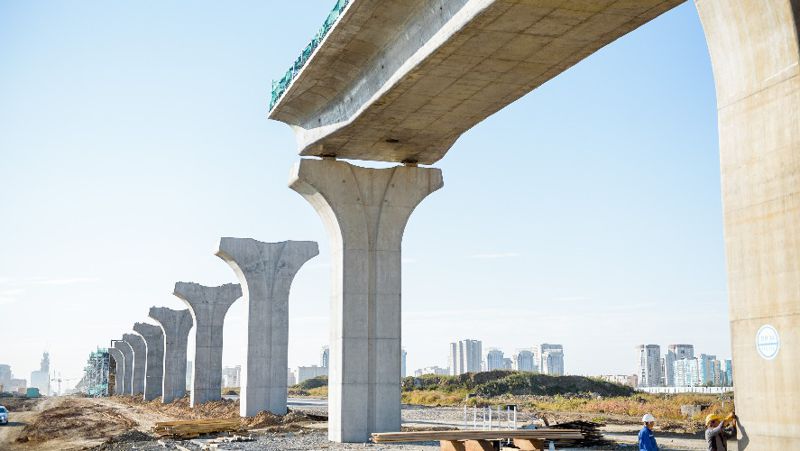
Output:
269,0,800,449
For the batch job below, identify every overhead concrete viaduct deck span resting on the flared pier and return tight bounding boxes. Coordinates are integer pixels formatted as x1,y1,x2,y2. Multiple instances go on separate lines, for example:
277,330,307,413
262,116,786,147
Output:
270,0,680,164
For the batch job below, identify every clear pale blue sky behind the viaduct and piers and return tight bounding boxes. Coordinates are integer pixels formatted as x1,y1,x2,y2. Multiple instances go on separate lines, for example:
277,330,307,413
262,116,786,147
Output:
0,1,730,388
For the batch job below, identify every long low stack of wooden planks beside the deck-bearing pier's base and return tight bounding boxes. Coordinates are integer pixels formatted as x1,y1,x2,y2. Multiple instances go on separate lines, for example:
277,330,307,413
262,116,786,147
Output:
372,428,583,443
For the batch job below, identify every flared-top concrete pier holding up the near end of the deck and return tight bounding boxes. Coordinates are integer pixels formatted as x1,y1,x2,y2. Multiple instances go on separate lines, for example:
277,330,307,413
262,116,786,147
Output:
289,159,443,442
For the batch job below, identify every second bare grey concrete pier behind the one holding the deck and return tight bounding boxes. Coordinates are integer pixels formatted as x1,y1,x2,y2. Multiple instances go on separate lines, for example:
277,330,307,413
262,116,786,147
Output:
173,282,242,407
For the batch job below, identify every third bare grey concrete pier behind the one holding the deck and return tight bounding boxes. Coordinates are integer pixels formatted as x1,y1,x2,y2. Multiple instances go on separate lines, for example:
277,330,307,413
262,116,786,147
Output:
150,307,194,403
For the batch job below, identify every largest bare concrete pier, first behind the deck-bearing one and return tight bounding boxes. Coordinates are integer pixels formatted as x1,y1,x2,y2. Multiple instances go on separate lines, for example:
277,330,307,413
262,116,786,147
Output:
216,238,319,417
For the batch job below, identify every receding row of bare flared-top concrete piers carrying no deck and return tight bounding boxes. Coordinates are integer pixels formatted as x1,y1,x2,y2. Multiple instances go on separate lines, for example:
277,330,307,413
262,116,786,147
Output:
109,238,319,416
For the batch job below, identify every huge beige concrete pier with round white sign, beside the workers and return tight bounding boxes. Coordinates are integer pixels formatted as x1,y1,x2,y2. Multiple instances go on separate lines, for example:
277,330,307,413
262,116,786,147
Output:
695,0,800,450
